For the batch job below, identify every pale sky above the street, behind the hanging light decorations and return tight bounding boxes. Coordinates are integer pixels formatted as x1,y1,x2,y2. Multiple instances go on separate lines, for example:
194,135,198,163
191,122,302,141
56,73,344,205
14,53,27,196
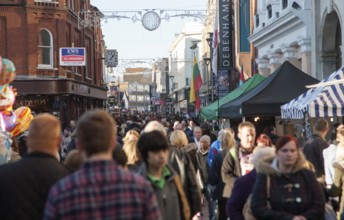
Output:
91,0,207,60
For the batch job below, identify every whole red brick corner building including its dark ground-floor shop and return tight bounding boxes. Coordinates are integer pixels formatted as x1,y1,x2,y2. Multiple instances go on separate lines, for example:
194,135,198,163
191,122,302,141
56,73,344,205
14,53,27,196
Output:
0,0,106,126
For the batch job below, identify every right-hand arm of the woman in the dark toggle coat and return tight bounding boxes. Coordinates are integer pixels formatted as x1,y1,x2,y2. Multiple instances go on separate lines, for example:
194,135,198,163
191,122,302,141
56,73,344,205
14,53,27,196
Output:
302,171,325,219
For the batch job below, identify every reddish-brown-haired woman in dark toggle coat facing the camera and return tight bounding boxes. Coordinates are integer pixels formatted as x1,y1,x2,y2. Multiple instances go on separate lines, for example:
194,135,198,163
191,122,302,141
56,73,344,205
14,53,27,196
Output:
251,135,325,220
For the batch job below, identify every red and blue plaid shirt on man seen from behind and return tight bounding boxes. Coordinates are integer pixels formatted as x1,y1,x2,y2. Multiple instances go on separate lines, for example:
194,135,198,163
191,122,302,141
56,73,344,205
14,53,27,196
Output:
44,161,161,220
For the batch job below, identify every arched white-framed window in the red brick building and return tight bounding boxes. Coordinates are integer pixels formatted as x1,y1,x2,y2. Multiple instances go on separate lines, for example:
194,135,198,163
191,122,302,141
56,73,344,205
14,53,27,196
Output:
37,29,53,67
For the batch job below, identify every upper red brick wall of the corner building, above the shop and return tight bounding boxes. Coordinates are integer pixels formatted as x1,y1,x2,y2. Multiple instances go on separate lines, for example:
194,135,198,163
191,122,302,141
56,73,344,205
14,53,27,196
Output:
0,0,103,86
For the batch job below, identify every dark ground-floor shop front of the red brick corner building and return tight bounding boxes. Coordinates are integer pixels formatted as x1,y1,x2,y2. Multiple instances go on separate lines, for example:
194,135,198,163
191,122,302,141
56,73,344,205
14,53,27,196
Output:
12,79,107,127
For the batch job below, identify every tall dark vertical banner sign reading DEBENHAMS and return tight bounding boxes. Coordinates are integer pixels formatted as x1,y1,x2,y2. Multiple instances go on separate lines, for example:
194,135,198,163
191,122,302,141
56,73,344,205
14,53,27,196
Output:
218,0,233,69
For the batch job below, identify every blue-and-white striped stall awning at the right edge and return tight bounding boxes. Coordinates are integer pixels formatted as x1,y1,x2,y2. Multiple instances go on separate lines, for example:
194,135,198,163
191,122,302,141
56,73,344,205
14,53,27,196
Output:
281,67,344,119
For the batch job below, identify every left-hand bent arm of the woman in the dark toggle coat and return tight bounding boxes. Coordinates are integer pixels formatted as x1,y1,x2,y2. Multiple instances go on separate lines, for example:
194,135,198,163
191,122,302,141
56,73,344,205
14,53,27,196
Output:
251,174,295,220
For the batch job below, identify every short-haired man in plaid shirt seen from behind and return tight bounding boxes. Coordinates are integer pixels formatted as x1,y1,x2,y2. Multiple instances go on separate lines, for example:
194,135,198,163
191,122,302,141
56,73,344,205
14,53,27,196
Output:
44,110,161,220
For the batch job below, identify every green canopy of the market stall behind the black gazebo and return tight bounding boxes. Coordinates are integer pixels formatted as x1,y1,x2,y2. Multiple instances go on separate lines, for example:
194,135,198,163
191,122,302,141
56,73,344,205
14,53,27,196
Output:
200,74,265,120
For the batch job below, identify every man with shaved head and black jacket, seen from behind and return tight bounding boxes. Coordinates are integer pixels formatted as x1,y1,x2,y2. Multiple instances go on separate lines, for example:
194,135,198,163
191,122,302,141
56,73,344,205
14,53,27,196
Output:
0,113,67,220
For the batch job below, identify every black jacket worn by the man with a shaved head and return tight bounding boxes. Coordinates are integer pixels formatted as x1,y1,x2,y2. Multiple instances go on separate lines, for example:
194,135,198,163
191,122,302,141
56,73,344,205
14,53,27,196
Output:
0,153,68,220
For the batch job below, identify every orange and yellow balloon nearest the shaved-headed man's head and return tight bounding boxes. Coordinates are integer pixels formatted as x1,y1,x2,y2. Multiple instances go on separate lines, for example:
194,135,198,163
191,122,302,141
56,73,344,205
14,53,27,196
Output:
10,106,33,137
